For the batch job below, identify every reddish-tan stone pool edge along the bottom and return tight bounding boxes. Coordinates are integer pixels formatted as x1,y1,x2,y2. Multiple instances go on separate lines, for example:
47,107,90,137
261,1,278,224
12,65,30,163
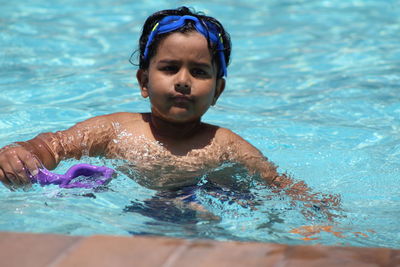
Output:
0,232,400,267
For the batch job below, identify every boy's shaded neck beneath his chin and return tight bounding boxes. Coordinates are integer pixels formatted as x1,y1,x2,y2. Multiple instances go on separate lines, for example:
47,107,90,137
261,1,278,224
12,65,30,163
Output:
150,115,201,139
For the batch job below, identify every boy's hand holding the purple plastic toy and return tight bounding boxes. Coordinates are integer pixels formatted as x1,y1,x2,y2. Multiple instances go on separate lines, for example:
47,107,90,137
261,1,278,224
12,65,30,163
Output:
0,144,41,190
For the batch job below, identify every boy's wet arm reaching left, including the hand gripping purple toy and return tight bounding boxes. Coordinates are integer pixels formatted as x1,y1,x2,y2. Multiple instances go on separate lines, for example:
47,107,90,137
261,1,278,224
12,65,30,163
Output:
0,114,118,188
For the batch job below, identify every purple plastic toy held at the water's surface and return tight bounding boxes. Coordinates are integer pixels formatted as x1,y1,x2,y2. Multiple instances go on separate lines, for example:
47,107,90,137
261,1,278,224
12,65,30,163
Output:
31,163,114,188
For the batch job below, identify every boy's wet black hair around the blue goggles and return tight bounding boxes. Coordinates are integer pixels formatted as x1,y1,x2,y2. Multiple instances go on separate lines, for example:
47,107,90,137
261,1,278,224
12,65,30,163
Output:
131,6,232,78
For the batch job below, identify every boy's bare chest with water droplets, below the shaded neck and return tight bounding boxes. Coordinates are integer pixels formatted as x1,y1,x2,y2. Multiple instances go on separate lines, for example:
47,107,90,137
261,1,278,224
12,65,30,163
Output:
107,135,226,189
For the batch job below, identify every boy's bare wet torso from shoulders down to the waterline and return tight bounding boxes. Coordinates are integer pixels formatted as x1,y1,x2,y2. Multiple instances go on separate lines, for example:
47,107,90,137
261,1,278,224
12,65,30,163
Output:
106,113,234,189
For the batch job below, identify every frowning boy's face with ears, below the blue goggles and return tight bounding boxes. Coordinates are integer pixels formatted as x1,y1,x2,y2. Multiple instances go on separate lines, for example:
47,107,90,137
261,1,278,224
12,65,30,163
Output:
137,32,225,123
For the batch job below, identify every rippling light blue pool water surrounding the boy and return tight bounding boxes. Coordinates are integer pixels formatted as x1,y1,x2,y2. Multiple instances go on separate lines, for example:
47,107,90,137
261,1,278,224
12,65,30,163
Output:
0,0,400,248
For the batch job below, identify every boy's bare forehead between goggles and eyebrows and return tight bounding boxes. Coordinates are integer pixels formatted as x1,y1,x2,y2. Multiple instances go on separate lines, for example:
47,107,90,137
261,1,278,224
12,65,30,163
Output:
153,31,212,63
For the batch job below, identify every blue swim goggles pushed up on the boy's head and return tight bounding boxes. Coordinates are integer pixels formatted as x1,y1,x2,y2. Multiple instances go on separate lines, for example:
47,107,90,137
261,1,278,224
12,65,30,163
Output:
143,15,227,77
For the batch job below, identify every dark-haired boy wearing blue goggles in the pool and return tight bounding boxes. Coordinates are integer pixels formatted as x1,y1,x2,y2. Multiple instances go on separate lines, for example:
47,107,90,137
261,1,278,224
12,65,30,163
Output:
0,7,335,214
